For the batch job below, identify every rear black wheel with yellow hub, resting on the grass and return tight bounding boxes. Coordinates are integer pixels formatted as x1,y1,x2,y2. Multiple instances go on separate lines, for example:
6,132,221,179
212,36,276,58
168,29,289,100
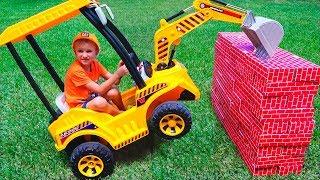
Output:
70,142,115,179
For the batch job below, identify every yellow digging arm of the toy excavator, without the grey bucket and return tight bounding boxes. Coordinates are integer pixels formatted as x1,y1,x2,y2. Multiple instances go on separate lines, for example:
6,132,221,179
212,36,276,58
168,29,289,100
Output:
154,0,247,65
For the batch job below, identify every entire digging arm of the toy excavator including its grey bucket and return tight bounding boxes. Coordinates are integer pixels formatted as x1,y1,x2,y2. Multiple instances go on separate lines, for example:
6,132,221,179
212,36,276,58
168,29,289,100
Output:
154,0,283,70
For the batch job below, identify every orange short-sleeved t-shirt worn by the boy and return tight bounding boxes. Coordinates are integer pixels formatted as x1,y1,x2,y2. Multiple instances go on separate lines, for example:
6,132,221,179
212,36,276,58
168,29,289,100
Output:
64,60,108,107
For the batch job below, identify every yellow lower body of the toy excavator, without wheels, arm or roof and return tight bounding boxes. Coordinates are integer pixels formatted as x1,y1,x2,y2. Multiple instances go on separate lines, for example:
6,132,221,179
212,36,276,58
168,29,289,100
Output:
49,61,200,151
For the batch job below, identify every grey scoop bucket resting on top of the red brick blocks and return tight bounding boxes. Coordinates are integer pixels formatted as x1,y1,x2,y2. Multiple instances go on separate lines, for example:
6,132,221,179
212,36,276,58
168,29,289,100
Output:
241,11,284,59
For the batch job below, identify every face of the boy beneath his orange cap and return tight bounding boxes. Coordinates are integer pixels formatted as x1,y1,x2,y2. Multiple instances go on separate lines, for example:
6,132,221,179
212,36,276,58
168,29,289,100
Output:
74,40,98,66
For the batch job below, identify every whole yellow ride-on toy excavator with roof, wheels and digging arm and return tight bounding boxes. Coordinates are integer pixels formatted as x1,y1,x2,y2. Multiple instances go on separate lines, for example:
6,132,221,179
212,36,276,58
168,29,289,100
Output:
0,0,283,178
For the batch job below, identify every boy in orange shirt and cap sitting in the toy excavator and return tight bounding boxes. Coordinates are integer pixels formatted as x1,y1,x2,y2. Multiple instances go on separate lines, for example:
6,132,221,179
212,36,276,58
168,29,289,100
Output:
64,32,128,116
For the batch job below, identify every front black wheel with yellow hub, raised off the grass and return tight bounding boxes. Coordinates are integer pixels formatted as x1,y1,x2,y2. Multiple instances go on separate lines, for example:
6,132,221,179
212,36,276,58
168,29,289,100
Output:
149,101,192,140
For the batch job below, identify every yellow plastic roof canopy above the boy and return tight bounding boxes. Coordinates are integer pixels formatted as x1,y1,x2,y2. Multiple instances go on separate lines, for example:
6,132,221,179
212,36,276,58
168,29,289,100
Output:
0,0,91,46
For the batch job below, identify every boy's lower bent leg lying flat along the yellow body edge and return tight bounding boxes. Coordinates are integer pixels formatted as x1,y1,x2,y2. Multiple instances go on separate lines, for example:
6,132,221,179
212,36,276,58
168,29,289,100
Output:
86,96,122,116
